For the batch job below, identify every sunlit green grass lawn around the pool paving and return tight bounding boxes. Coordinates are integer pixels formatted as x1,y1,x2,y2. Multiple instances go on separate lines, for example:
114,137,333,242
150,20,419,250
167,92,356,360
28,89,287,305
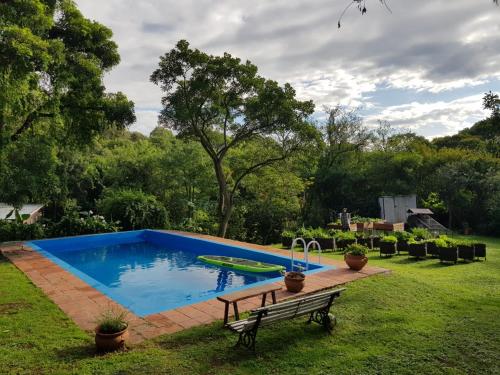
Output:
0,238,500,374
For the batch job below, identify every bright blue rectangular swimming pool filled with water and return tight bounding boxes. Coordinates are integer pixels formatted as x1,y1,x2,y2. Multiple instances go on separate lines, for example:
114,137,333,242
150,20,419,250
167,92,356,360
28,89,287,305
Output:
28,230,332,316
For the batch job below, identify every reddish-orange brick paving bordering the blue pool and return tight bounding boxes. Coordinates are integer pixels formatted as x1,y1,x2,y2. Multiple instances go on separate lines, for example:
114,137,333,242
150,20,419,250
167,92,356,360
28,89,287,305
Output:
0,231,390,344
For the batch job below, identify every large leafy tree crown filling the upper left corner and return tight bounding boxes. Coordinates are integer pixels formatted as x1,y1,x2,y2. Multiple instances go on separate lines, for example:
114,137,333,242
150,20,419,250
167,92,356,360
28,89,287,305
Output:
0,0,135,148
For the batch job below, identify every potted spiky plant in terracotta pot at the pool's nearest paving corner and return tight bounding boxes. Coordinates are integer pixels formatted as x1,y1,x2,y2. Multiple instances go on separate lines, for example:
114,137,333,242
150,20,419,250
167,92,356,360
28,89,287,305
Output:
95,310,128,352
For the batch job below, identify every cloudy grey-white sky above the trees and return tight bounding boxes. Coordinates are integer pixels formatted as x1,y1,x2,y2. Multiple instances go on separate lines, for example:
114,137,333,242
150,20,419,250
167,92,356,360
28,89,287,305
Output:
77,0,500,138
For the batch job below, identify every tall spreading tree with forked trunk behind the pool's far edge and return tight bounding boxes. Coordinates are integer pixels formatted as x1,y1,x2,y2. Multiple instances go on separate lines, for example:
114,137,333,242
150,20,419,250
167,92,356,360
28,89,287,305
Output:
151,40,315,237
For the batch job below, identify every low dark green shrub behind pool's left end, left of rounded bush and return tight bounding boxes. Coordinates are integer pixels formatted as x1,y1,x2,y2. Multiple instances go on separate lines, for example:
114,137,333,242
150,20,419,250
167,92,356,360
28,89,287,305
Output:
48,213,120,237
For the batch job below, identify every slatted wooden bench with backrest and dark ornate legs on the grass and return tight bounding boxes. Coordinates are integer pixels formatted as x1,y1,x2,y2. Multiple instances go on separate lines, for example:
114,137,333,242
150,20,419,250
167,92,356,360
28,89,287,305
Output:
227,288,345,350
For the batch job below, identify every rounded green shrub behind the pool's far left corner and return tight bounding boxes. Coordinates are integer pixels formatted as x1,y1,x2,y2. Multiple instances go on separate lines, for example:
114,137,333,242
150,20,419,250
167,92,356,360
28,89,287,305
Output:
98,190,167,230
